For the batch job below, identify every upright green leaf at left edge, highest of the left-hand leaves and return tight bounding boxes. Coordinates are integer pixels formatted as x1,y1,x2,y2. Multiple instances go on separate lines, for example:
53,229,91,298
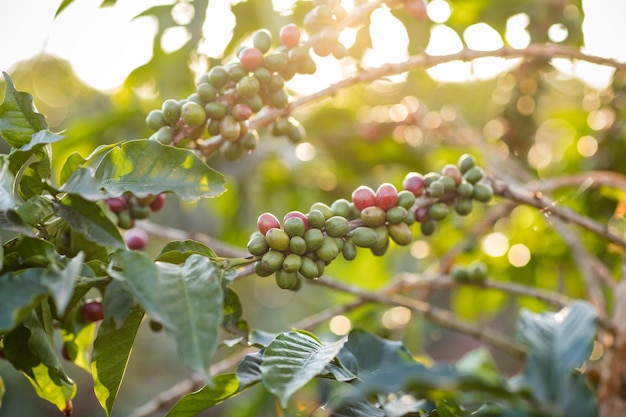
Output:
0,72,48,148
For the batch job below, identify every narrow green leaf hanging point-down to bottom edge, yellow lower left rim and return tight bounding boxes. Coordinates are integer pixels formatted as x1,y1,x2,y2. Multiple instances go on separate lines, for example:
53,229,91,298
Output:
91,308,144,416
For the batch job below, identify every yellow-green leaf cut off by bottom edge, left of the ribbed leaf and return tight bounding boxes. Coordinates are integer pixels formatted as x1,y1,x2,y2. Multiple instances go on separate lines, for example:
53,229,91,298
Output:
165,374,241,417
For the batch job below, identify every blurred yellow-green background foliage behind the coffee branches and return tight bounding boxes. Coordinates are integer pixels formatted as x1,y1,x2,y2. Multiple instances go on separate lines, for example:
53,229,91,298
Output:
0,0,626,417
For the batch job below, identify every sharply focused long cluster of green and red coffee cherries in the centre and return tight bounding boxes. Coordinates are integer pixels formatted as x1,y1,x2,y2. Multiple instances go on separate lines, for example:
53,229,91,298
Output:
247,154,493,290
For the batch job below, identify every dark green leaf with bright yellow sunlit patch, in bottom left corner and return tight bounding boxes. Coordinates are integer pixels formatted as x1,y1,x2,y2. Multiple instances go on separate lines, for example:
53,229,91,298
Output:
3,313,76,413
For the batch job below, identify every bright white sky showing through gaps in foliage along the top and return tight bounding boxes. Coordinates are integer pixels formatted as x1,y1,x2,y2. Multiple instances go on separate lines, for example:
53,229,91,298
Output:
0,0,626,92
